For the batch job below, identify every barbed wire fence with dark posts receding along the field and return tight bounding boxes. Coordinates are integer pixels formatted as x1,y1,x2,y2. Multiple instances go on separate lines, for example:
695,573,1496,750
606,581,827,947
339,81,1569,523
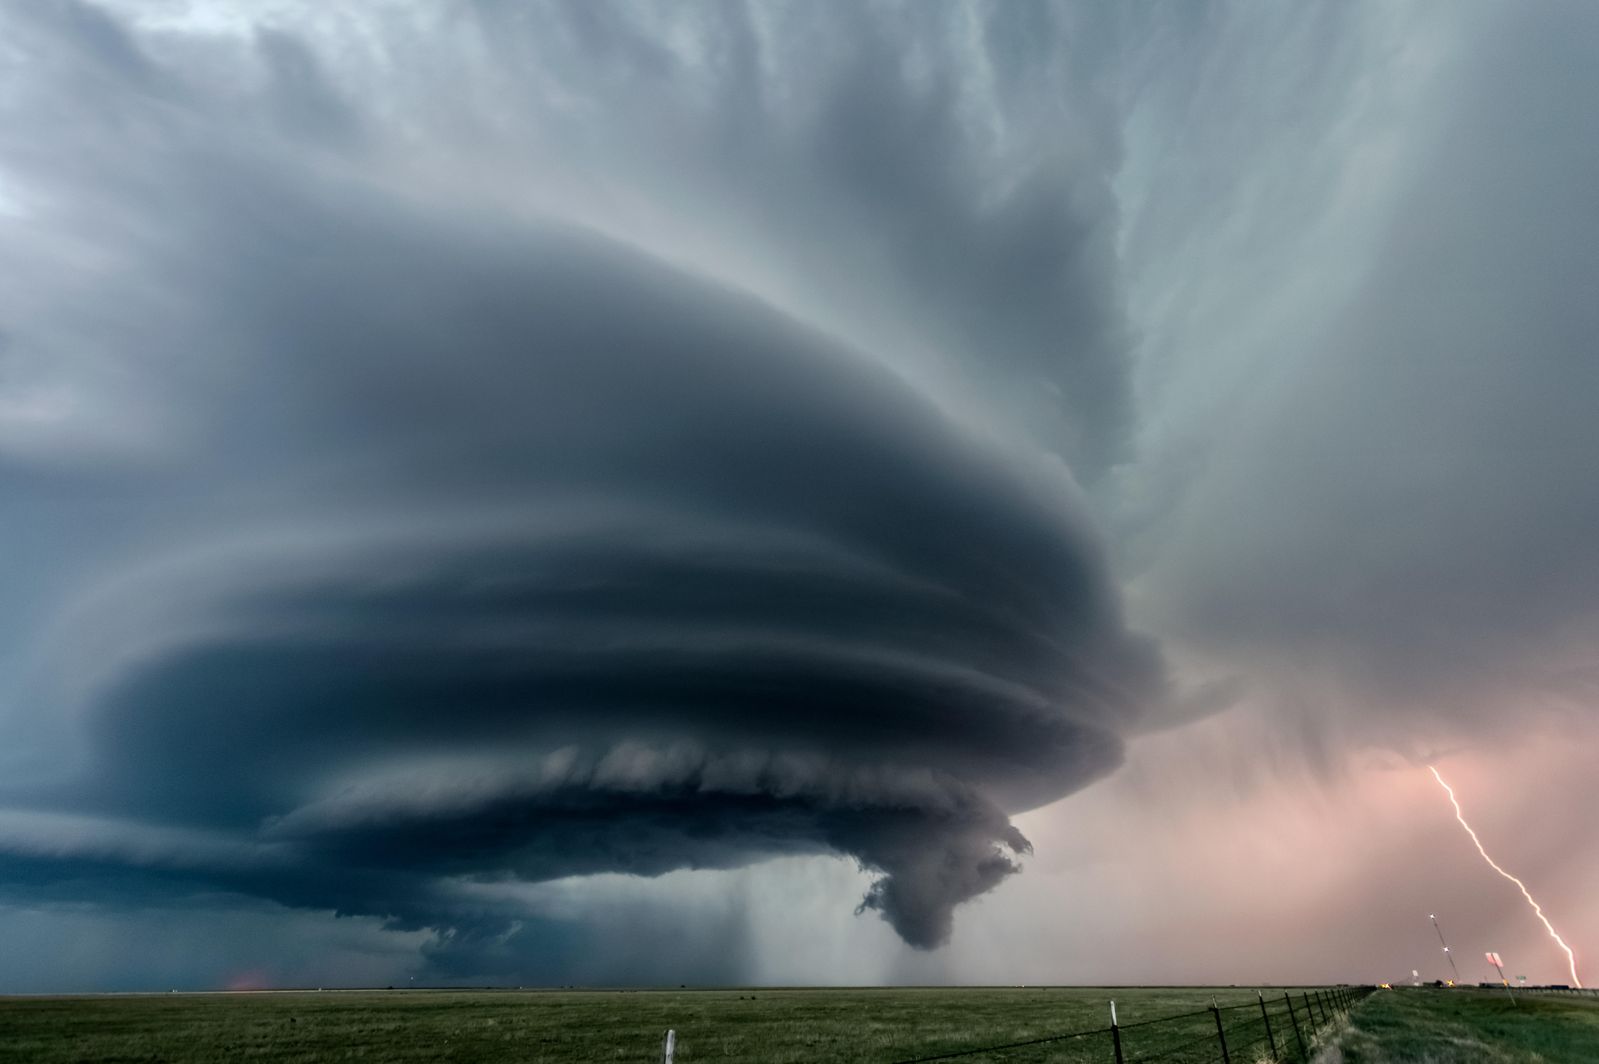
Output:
891,986,1375,1064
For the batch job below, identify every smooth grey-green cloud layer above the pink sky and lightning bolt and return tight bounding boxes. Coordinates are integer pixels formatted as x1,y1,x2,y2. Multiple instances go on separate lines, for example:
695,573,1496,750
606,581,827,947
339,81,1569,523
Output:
1127,3,1599,755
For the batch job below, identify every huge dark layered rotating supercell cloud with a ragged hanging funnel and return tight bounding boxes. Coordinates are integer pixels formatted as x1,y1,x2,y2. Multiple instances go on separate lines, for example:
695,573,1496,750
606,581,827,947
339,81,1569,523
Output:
0,3,1162,953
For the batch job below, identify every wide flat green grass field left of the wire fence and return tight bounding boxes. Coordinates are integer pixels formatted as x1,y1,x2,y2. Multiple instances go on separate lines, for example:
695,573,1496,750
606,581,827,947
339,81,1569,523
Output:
0,987,1362,1064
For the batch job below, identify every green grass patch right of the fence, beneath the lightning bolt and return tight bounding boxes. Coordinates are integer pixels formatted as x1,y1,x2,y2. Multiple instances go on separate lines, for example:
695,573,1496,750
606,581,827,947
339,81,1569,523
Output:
1338,989,1599,1064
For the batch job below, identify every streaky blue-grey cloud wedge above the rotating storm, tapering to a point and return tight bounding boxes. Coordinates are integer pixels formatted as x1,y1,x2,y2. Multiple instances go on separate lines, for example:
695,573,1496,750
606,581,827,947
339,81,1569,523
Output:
469,2,1129,477
